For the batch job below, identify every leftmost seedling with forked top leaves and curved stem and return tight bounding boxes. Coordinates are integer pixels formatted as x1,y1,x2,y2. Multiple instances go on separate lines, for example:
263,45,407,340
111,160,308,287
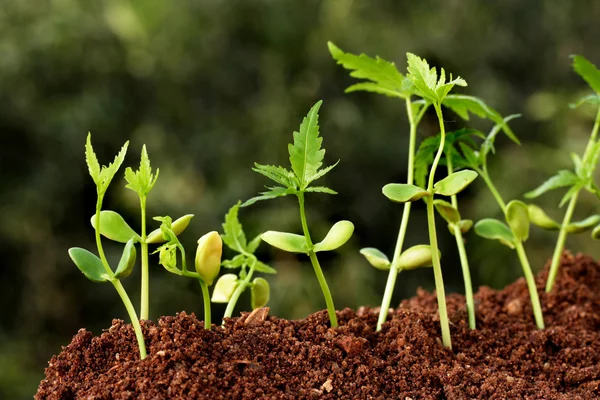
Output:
69,134,146,360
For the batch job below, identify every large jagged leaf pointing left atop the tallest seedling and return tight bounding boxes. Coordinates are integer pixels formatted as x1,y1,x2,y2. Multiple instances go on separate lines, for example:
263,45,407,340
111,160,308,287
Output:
327,42,411,99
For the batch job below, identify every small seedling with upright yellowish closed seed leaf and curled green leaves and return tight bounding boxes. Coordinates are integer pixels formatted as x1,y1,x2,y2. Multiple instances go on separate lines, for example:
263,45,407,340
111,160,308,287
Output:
154,216,223,330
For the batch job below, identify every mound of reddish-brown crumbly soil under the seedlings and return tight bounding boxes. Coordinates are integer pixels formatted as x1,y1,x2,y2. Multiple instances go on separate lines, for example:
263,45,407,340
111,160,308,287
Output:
35,253,600,400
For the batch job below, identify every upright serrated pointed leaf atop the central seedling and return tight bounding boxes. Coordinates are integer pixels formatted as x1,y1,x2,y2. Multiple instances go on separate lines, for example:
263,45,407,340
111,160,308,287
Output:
288,100,325,190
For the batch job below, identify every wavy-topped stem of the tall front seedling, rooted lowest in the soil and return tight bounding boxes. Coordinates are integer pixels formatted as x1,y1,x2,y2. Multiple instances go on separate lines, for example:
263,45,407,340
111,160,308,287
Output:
425,103,452,349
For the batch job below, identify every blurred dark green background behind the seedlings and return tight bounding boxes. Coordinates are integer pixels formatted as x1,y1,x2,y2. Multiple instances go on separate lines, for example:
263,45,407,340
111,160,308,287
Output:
0,0,600,399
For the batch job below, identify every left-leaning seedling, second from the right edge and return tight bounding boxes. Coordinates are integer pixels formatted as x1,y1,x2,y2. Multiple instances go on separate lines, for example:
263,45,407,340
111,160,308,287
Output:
452,115,544,329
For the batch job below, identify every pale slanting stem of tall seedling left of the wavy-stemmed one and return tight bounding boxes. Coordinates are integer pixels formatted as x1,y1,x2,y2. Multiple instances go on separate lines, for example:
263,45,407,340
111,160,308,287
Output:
377,97,418,331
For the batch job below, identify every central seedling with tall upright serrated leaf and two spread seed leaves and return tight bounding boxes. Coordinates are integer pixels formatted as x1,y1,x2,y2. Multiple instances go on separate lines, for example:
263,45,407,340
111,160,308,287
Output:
242,101,354,327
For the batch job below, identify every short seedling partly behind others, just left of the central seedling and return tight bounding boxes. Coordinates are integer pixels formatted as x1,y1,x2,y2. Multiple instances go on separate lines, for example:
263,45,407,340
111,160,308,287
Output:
211,202,277,321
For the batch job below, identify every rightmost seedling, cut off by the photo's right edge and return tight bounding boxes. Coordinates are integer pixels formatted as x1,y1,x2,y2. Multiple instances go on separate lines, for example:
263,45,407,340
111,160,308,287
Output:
525,56,600,292
